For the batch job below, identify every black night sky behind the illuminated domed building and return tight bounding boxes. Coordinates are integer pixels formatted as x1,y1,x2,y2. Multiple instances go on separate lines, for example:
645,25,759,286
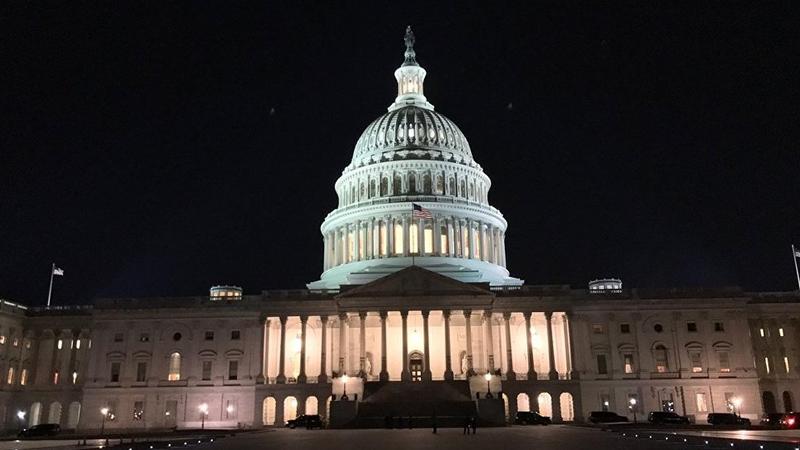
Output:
0,0,800,304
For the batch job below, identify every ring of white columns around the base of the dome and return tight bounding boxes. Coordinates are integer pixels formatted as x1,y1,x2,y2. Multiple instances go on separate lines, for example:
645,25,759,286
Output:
323,215,506,270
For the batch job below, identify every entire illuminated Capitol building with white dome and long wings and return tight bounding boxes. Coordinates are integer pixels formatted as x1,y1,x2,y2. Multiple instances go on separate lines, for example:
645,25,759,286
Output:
0,29,800,430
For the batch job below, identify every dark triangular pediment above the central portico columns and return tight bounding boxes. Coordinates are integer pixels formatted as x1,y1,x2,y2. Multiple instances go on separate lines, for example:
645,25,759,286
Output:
336,266,494,299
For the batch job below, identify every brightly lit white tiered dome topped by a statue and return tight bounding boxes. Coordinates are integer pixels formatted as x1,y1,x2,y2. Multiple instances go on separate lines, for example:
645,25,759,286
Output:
308,27,522,290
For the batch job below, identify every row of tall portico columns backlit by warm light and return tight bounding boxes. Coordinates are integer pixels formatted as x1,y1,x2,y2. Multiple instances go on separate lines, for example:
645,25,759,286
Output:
258,309,578,384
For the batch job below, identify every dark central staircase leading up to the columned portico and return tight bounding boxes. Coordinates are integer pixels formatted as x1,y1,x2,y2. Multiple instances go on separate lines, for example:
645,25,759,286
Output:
349,381,477,428
